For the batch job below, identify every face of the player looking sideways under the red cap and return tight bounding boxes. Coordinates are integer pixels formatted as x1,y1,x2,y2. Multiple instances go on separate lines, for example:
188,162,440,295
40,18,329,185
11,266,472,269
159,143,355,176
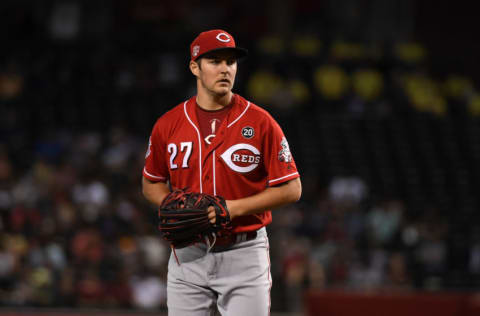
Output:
198,51,237,96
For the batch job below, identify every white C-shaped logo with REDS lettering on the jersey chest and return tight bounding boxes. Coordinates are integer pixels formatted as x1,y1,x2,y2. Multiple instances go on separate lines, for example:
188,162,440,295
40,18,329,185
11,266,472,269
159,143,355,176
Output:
220,144,260,173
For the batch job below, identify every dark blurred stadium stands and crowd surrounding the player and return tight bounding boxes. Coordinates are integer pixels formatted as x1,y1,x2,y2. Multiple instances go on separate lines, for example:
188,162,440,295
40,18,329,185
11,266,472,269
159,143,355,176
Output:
0,0,480,315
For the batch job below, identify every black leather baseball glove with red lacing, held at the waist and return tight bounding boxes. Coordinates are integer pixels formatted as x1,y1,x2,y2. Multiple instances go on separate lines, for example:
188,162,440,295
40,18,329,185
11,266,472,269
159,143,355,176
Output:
158,189,231,248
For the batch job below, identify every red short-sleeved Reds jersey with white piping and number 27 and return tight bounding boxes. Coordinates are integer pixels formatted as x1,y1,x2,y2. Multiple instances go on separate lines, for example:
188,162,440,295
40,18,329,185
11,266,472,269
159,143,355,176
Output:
143,94,299,233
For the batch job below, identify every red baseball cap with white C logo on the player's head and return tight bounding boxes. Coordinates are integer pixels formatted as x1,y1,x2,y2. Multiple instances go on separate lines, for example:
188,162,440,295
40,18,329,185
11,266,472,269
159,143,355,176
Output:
190,30,248,61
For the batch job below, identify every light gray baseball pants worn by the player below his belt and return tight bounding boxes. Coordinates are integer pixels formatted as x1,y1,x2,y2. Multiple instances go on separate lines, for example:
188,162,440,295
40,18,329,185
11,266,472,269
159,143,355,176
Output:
167,227,272,316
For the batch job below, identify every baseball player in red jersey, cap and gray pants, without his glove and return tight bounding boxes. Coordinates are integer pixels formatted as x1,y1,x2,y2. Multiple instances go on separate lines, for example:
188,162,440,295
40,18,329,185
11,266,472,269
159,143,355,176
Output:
142,30,302,316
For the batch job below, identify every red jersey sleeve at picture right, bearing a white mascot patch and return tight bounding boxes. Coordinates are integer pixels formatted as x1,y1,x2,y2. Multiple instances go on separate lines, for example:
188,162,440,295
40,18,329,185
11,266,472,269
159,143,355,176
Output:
264,117,300,186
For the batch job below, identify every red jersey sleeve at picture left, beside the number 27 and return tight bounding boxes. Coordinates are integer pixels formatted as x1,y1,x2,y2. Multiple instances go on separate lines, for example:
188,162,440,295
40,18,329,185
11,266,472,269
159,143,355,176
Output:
143,121,168,182
